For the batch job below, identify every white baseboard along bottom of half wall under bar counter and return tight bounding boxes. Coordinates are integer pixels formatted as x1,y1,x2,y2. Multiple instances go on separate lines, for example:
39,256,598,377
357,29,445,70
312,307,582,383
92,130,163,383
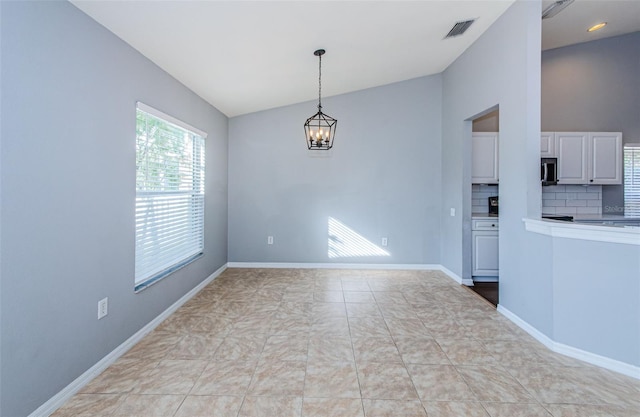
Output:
498,305,640,379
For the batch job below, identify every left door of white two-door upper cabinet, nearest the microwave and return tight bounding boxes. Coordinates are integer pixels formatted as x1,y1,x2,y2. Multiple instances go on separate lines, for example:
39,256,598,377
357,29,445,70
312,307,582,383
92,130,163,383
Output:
556,132,589,184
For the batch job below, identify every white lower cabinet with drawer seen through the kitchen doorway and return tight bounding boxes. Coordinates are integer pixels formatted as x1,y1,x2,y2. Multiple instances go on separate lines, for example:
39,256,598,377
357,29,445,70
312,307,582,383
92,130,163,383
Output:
471,219,499,277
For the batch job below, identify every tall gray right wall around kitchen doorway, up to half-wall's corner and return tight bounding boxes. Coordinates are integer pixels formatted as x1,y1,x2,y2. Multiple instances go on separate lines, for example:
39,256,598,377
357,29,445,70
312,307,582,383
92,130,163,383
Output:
442,1,553,333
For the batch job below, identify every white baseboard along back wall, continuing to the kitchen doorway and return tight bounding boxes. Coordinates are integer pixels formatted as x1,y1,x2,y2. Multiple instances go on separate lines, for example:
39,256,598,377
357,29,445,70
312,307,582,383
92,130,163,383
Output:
227,262,473,286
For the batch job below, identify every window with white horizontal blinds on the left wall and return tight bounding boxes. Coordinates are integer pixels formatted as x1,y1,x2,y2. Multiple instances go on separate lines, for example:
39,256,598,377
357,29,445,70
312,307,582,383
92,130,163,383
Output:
135,103,206,291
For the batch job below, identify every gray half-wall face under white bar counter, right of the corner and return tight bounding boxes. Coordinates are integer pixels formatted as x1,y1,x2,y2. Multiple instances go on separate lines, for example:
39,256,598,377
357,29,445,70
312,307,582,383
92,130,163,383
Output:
545,236,640,367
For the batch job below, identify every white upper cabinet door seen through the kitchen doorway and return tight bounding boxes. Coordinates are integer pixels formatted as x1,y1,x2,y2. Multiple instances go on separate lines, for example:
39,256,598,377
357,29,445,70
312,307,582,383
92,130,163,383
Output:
471,132,498,184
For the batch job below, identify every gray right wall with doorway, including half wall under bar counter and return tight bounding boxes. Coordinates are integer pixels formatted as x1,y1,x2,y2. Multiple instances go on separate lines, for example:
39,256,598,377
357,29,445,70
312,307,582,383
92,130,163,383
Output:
442,7,640,366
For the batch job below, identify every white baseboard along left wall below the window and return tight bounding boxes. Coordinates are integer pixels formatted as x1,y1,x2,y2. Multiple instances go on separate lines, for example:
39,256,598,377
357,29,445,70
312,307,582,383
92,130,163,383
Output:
29,264,227,417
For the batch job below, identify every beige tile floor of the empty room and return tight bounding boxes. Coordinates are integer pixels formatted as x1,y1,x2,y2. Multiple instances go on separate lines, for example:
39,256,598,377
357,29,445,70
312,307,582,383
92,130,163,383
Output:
54,269,640,417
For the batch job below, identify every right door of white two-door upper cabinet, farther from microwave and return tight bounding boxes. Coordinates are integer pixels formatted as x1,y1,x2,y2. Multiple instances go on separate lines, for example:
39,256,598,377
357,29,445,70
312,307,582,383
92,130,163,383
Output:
589,132,622,184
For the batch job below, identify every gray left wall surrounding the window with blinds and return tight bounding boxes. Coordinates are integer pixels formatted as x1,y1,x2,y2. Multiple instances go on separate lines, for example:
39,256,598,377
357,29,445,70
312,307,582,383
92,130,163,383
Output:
0,1,227,417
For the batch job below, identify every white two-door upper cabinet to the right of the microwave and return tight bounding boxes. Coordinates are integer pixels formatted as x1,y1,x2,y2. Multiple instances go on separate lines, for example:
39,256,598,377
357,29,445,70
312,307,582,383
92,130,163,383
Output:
552,132,622,185
